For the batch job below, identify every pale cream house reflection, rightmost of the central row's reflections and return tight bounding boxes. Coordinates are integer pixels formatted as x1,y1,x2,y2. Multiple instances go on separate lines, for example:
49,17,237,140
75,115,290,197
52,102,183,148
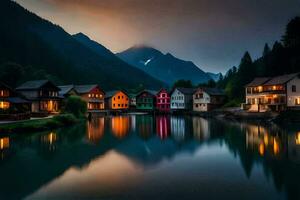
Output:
193,117,210,140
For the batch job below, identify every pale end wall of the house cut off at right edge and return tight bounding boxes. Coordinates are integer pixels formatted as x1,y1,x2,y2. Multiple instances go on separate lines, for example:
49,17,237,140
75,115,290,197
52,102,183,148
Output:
286,77,300,108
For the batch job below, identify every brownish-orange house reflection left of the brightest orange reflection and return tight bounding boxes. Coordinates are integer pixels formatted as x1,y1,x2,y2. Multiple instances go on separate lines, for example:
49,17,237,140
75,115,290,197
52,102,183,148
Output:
87,117,105,143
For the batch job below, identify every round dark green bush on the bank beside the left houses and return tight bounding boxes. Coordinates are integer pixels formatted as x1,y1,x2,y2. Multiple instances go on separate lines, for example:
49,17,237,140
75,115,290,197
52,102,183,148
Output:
63,96,87,118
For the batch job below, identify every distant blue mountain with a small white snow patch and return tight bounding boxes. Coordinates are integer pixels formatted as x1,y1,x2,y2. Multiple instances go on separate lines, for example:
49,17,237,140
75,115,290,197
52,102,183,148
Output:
116,45,211,85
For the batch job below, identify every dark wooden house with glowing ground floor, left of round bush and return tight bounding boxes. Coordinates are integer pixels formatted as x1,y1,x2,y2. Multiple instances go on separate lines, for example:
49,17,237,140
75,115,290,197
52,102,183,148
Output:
16,80,61,113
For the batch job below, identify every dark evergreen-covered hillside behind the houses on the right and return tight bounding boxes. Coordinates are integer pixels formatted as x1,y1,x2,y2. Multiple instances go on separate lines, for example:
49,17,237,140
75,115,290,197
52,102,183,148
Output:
217,17,300,102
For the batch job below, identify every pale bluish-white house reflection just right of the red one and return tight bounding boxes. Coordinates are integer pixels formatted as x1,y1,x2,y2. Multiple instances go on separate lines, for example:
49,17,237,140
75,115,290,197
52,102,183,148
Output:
171,116,188,141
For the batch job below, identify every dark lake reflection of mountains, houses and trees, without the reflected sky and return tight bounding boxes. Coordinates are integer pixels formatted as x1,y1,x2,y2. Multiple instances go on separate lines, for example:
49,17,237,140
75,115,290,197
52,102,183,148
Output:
0,115,300,199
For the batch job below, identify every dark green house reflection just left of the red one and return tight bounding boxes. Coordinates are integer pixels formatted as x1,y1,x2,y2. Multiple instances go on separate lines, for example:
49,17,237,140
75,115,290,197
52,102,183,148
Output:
136,115,154,138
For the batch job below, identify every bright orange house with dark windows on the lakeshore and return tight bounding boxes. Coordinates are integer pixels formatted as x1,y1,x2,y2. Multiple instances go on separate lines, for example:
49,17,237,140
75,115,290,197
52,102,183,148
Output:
105,90,129,110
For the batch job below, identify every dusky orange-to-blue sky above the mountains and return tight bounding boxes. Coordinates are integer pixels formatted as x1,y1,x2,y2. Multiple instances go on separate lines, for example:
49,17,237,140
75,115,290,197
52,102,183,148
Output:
15,0,300,73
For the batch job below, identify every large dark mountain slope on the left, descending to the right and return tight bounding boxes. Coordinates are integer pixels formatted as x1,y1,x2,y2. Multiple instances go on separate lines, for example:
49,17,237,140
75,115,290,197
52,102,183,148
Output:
0,0,162,89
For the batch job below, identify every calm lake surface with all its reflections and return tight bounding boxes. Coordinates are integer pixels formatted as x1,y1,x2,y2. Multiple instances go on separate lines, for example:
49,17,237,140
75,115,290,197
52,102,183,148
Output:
0,115,300,200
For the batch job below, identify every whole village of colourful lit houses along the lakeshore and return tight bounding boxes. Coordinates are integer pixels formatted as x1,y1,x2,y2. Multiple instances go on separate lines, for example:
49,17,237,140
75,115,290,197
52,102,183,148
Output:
0,73,300,121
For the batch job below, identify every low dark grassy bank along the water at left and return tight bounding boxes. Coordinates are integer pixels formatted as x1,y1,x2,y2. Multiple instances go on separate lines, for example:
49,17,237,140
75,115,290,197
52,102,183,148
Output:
0,114,83,133
